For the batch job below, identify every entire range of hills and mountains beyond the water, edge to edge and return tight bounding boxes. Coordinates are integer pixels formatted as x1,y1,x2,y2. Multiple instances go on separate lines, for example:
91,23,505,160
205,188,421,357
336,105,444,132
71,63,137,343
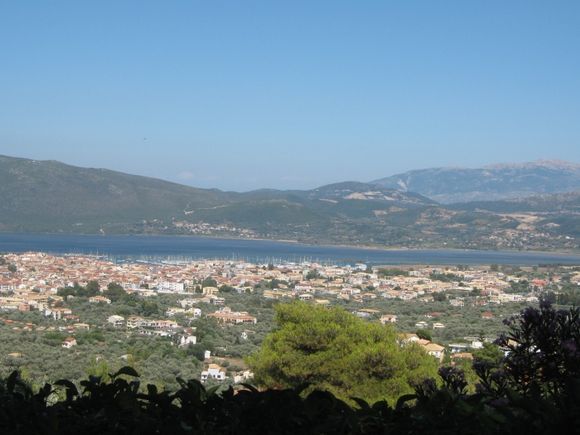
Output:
0,156,580,250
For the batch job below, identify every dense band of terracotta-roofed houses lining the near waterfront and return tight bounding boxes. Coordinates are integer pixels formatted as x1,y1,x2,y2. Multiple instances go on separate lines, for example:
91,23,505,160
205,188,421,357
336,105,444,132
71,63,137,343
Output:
0,253,568,309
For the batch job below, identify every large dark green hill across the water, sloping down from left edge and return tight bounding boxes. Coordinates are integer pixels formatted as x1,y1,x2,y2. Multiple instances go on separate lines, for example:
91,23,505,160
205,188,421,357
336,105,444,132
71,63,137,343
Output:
0,156,238,231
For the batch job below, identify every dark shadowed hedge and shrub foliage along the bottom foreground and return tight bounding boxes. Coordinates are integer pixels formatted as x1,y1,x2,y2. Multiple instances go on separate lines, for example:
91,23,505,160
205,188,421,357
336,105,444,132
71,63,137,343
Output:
0,303,580,434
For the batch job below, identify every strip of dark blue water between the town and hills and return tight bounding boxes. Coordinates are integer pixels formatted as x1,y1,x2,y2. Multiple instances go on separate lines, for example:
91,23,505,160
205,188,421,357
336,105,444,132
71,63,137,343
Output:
0,233,580,266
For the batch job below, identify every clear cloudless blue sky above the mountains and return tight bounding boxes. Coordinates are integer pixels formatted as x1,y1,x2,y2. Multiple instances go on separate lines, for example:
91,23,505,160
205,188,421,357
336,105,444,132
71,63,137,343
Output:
0,0,580,190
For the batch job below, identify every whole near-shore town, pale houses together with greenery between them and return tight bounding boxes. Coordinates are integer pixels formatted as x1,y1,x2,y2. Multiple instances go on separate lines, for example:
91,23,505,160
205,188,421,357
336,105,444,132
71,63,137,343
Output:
0,252,580,383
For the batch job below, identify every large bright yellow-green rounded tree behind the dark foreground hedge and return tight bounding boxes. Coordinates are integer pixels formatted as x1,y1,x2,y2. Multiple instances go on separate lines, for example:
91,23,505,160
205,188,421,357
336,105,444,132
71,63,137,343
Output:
247,302,437,402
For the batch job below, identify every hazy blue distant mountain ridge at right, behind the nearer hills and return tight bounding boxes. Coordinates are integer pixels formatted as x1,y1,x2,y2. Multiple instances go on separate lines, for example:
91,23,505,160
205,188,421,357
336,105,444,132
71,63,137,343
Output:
372,160,580,204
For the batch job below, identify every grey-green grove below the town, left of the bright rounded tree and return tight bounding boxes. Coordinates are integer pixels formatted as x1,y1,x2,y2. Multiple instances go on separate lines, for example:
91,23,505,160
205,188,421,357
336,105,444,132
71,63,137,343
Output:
0,290,273,388
